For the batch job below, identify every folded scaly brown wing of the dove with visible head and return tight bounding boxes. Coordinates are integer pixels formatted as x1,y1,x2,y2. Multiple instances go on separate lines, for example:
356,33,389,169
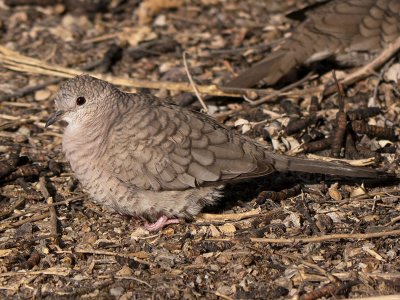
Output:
106,95,274,190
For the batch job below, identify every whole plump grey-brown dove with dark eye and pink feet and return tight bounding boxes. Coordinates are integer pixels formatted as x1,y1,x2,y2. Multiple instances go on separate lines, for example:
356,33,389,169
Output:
46,75,384,229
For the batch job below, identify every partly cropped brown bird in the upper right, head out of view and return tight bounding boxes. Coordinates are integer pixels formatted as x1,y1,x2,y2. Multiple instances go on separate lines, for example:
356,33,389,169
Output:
224,0,400,88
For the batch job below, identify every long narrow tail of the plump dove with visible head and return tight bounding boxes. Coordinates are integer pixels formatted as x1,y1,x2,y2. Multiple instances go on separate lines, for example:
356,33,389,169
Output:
265,152,393,178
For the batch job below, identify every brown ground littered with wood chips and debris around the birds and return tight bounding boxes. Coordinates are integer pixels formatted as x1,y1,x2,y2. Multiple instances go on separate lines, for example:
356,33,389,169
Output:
0,0,400,299
